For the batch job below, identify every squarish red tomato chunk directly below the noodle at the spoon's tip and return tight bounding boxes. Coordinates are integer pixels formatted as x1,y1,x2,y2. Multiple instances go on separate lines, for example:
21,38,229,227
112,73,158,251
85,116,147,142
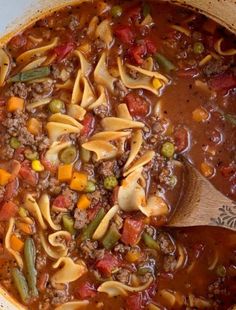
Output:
121,218,144,245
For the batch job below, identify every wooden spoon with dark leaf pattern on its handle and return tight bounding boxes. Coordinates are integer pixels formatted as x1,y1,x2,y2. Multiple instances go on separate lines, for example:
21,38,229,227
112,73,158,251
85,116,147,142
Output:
168,160,236,231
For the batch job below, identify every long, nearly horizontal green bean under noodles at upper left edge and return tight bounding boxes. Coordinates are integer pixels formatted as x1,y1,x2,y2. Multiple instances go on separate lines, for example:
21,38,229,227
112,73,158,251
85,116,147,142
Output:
8,67,51,83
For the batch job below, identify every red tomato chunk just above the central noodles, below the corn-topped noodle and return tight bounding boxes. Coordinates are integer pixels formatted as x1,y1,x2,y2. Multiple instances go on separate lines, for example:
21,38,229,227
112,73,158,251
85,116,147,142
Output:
124,93,149,117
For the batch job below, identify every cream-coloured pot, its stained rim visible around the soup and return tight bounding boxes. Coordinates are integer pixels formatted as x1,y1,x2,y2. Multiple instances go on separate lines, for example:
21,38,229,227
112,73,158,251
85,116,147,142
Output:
0,0,236,310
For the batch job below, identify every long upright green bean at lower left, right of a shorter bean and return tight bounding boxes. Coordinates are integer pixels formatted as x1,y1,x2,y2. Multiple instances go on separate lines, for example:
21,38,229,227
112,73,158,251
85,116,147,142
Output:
24,238,38,297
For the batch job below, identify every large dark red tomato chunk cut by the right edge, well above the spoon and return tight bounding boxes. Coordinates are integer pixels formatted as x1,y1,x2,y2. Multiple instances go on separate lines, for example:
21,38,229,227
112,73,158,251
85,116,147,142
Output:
209,73,236,91
